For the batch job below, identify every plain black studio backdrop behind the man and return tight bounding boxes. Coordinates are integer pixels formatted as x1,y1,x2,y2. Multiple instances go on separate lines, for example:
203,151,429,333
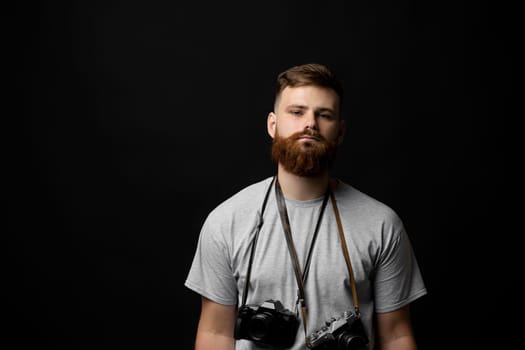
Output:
2,1,512,350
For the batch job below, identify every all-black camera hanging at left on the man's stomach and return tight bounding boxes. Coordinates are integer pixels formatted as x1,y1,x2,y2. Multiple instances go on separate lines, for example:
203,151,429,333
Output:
234,299,299,348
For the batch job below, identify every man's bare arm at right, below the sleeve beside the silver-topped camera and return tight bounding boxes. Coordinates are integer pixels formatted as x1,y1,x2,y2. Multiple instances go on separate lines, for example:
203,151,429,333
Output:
376,305,416,350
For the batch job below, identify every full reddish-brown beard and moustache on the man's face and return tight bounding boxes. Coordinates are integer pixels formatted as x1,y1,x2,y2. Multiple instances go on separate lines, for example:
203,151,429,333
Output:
272,129,337,177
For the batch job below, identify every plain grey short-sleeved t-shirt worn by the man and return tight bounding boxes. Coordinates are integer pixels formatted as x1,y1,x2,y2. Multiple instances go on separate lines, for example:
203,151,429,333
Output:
185,177,427,350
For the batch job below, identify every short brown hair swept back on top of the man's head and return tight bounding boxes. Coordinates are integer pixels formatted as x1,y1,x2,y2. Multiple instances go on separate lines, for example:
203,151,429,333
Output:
275,63,343,102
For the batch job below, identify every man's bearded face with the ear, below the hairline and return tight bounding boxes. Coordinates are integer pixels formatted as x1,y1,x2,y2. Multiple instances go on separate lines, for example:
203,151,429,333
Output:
268,85,344,176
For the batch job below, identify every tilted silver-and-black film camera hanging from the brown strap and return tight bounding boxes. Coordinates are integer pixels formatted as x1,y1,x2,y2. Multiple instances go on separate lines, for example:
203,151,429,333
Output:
306,311,368,350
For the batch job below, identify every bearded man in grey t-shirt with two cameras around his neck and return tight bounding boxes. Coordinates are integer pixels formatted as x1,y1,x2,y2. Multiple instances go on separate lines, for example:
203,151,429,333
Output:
185,64,426,350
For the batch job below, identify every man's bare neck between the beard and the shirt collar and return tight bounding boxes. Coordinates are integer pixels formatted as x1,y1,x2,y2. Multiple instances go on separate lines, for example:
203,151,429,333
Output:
277,164,330,201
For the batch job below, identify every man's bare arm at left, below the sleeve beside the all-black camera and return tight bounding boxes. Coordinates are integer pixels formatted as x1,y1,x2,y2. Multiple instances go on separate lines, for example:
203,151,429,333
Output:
195,297,236,350
